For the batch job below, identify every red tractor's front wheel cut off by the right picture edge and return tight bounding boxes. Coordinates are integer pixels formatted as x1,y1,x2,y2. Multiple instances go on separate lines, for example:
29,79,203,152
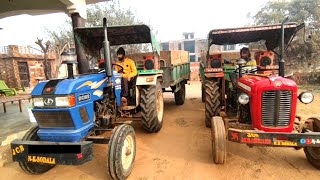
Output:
303,118,320,169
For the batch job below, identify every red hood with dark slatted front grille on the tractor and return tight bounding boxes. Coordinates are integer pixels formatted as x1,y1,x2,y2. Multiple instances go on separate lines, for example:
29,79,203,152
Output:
237,75,298,132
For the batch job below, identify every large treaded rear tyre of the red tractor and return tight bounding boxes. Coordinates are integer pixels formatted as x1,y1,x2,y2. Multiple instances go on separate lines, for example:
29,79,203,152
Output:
205,80,220,128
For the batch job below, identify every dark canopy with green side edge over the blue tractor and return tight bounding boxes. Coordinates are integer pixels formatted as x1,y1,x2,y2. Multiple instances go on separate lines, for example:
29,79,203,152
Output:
74,25,160,54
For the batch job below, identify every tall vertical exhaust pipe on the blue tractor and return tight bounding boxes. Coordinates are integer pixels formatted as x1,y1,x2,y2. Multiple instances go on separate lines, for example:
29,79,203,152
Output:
103,18,113,77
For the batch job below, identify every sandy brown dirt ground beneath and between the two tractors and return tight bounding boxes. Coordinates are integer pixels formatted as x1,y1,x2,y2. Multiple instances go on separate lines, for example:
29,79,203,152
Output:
0,84,320,180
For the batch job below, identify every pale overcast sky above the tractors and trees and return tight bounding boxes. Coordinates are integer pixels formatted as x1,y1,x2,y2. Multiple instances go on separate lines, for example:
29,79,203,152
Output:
0,0,268,46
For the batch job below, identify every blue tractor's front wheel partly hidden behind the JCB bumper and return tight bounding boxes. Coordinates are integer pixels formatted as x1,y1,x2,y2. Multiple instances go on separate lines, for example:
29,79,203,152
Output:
19,126,55,174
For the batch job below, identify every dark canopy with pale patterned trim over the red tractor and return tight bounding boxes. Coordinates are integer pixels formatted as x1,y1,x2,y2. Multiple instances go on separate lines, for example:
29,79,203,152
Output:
208,22,304,50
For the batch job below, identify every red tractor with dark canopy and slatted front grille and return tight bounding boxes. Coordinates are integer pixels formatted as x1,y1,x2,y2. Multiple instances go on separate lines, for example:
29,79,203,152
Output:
202,18,320,169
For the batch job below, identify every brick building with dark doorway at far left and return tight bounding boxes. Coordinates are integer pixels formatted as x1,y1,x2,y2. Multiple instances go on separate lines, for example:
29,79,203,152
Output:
0,45,55,87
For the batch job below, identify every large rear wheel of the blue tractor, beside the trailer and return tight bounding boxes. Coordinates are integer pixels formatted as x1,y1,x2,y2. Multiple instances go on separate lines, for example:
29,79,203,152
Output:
140,82,164,132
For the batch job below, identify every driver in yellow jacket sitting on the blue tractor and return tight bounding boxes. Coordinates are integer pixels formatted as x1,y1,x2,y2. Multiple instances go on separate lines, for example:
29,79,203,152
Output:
114,47,138,101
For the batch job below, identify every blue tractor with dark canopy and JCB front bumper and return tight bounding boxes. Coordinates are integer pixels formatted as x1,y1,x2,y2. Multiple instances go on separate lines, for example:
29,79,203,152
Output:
11,19,163,179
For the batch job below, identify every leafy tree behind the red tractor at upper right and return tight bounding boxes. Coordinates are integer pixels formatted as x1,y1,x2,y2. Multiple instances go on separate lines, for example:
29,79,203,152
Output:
252,0,320,78
